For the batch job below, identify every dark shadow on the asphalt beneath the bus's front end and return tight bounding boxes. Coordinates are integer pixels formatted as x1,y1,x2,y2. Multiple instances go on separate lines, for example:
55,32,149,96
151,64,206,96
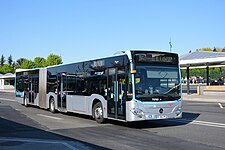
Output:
108,112,200,129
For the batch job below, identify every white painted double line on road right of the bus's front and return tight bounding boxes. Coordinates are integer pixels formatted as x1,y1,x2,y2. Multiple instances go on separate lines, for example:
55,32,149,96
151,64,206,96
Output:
169,119,225,128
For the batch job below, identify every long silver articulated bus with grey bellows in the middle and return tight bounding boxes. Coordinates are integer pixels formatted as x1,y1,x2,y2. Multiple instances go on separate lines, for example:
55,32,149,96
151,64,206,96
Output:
16,50,182,123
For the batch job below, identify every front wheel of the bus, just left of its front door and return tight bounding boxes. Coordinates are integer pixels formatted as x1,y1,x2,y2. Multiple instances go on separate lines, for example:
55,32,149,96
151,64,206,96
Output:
92,102,105,123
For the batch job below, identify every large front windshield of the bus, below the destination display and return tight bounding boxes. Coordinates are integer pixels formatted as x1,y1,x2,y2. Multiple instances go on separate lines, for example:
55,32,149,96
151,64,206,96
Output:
135,65,181,101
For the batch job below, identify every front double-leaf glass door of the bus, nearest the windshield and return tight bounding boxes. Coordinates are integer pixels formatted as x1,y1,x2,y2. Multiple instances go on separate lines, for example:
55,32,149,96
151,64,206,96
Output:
107,68,126,120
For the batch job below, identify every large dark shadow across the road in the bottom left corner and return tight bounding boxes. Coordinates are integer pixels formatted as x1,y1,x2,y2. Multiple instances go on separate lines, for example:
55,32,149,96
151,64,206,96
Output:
0,116,108,150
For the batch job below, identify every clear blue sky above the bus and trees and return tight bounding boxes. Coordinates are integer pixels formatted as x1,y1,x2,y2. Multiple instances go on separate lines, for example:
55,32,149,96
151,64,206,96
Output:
0,0,225,63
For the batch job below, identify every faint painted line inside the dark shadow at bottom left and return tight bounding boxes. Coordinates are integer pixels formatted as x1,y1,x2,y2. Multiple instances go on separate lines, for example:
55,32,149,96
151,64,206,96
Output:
0,137,81,150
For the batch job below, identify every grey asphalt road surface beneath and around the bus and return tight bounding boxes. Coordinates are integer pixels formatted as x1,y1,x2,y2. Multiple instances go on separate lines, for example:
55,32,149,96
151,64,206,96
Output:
0,92,225,150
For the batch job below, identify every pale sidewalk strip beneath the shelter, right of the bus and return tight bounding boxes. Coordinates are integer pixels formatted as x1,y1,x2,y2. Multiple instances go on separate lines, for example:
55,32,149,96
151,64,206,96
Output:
182,93,225,103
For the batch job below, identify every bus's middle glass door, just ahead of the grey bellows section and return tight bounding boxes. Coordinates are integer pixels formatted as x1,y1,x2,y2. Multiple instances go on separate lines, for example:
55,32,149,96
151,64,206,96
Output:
57,73,67,110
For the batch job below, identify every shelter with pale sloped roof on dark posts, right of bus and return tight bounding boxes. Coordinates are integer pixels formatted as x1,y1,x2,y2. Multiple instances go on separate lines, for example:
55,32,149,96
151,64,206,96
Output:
180,51,225,94
